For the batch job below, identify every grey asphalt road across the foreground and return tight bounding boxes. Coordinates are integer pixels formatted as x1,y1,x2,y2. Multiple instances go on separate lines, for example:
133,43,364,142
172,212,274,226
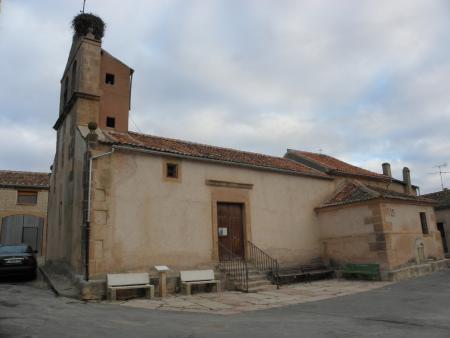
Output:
0,270,450,338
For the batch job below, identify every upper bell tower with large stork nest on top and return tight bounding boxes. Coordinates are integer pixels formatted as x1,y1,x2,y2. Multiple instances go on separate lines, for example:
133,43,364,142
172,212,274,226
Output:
54,13,133,132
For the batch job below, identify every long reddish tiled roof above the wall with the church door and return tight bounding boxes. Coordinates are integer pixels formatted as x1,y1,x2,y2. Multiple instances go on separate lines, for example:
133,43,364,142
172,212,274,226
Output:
102,130,329,178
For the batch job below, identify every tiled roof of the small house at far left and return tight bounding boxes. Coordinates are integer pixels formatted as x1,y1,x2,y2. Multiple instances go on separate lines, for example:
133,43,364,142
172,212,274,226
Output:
0,170,50,189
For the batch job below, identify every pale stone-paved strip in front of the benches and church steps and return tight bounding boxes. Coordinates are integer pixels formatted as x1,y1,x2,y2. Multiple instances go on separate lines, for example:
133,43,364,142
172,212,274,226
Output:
118,279,391,315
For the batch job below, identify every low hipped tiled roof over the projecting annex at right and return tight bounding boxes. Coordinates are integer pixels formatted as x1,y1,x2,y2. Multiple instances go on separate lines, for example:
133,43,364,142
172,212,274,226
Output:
319,181,436,208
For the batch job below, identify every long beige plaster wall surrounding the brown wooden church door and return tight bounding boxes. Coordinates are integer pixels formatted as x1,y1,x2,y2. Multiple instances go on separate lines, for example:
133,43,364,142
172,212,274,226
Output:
90,149,333,276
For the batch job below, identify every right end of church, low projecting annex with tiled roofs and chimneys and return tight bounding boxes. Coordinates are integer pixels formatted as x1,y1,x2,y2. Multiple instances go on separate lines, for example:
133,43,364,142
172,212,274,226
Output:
285,150,442,271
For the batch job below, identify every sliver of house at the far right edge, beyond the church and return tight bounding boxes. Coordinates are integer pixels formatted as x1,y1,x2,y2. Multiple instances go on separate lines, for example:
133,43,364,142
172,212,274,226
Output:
424,189,450,254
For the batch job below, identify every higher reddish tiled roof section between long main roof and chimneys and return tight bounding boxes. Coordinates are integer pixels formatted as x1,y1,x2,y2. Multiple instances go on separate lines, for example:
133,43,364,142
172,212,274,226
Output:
286,149,390,180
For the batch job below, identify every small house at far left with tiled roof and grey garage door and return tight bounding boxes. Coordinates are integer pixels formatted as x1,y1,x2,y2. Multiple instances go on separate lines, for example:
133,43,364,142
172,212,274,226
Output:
0,170,50,255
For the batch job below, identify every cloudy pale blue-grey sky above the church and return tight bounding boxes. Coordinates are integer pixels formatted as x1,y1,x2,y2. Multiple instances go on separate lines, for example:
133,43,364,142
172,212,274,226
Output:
0,0,450,192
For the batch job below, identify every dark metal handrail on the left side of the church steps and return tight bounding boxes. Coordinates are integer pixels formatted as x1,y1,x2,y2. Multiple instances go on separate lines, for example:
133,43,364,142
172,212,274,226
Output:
219,243,248,292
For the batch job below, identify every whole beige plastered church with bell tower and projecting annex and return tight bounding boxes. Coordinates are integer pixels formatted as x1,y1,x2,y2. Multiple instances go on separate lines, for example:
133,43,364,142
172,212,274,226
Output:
47,15,443,298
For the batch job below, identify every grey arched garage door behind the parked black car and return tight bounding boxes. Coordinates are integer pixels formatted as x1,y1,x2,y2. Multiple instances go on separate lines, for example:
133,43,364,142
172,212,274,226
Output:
0,215,44,254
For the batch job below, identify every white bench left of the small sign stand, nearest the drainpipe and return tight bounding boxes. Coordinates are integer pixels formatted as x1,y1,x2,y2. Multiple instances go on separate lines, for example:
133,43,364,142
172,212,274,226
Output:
106,273,155,300
